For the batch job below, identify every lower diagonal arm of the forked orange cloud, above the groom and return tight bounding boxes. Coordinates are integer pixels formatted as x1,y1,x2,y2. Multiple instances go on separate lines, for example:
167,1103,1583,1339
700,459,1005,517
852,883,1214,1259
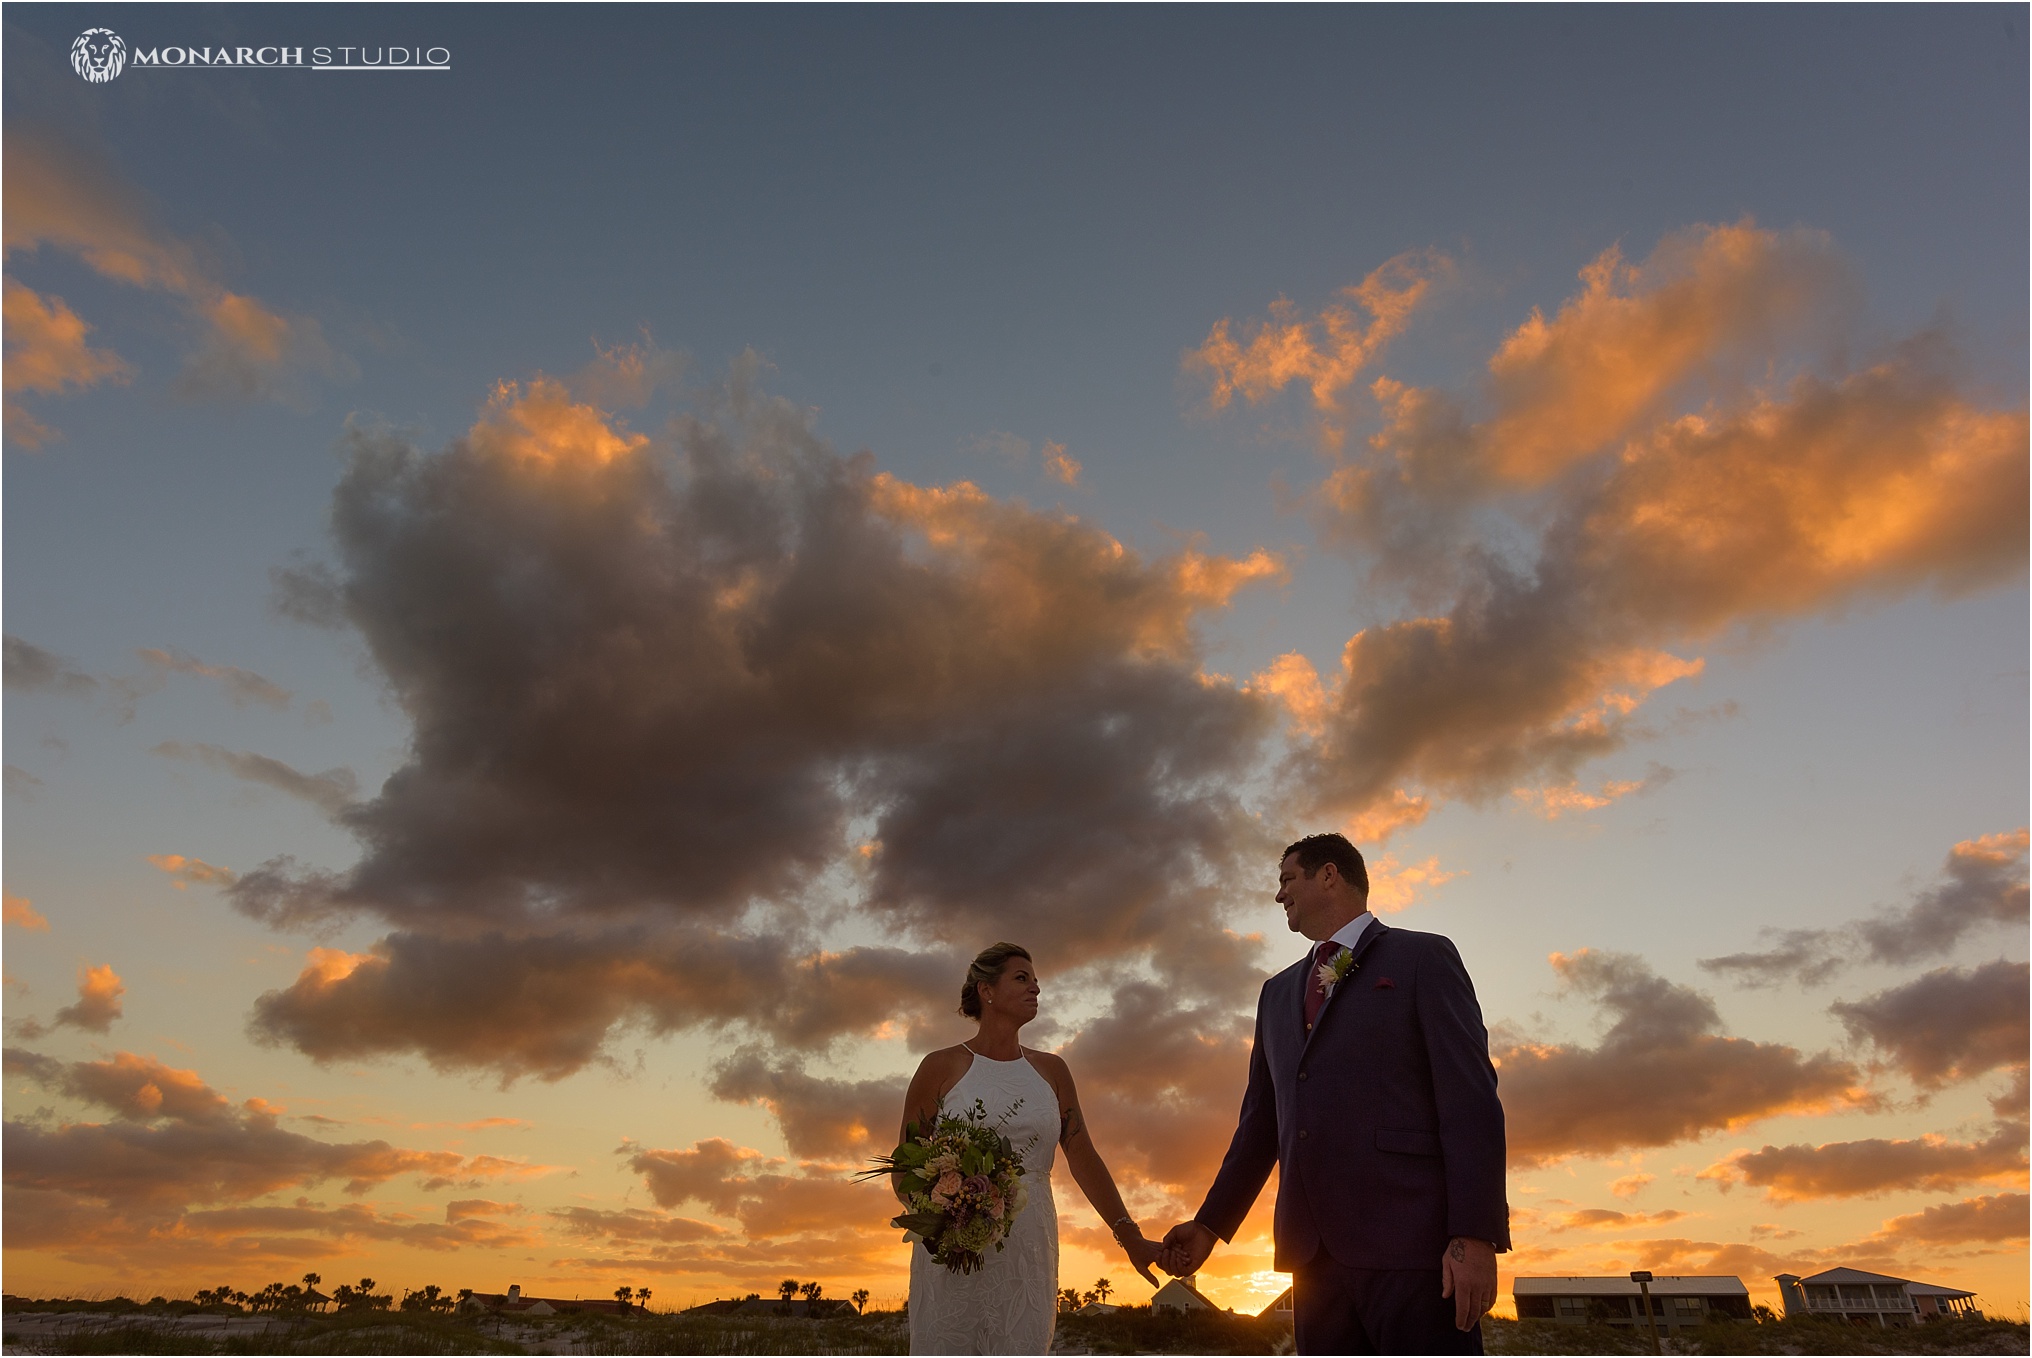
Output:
1298,339,2026,809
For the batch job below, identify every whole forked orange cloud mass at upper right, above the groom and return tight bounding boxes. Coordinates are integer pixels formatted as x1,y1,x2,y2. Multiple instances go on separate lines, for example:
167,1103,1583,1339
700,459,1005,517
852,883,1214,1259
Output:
1259,224,2028,829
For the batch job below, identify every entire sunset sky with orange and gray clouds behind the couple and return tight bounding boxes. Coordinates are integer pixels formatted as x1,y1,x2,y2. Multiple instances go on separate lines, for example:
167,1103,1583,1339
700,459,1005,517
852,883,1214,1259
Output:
0,4,2028,1315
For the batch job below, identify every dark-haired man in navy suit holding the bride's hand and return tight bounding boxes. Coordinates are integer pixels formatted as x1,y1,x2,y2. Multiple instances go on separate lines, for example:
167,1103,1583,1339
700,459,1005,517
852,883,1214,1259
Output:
1160,834,1510,1354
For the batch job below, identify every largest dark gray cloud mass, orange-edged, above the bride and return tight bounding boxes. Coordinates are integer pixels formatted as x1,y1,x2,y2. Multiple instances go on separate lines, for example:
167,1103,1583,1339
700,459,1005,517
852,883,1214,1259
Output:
237,365,1280,1075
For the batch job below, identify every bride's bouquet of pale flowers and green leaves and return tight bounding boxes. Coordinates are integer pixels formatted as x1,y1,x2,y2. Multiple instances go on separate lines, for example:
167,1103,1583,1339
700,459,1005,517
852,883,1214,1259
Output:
862,1100,1030,1273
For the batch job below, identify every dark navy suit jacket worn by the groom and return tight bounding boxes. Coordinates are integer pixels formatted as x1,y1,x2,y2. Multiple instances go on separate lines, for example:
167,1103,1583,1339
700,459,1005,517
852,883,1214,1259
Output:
1197,921,1510,1273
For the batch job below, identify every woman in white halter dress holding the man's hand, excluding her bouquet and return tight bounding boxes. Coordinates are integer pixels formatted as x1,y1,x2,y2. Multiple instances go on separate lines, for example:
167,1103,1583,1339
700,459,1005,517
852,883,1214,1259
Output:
892,943,1162,1354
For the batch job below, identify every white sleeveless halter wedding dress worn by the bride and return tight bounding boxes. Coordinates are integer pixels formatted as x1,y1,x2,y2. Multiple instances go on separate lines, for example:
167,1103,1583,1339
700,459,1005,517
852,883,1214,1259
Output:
910,1053,1059,1354
